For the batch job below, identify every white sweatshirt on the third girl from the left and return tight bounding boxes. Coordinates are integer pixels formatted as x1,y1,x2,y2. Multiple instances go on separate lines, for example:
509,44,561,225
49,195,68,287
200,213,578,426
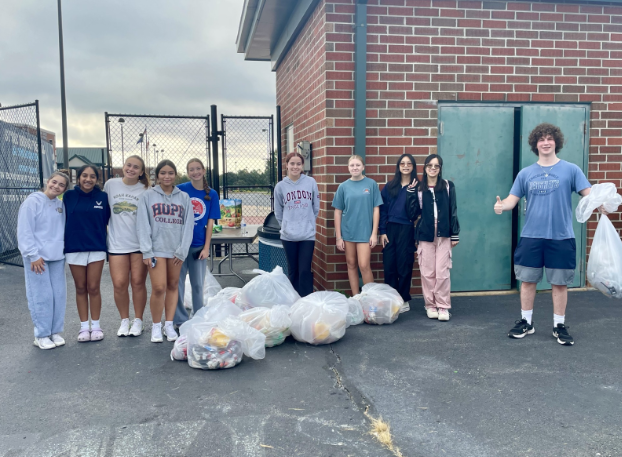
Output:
104,178,147,254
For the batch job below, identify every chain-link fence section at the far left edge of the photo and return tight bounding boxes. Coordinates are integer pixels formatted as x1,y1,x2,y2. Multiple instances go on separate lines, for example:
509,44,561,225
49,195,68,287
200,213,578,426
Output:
0,101,50,266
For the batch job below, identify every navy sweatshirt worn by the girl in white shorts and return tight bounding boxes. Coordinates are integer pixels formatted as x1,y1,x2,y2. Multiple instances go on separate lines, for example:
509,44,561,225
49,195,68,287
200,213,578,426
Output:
63,187,110,254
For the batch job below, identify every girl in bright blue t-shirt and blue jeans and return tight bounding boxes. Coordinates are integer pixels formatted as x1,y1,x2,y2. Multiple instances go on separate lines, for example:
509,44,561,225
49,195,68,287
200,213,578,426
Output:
174,159,220,325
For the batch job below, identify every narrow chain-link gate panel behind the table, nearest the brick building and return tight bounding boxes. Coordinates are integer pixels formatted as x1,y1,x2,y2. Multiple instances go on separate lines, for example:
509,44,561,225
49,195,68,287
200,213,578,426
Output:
221,115,276,253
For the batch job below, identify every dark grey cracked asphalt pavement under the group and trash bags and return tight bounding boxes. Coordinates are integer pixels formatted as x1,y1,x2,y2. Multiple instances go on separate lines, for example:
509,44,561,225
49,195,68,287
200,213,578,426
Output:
0,260,622,457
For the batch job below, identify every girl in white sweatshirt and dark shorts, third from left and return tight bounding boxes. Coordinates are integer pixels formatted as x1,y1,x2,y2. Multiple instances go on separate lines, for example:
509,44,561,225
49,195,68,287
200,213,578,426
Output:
104,155,149,336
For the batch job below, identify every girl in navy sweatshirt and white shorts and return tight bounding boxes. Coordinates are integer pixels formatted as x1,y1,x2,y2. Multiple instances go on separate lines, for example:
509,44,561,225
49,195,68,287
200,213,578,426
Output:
63,165,110,343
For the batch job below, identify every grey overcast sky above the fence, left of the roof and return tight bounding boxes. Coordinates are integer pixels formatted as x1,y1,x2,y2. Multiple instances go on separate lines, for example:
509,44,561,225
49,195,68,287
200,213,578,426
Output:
0,0,276,147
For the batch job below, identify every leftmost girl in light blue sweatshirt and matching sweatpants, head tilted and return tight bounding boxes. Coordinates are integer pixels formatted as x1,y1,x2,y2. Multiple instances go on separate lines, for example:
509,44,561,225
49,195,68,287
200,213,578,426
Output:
17,171,69,349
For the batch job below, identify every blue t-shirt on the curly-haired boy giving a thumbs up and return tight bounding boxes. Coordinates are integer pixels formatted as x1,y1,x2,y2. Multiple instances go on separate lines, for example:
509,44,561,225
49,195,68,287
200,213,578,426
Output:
510,160,592,240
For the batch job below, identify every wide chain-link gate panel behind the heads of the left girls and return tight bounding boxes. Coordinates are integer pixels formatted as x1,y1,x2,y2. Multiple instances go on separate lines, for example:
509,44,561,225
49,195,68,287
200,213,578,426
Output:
105,113,211,184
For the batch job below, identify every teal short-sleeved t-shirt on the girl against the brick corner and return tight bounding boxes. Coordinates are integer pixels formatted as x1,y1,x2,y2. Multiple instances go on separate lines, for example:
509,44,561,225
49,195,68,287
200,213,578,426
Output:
333,177,382,243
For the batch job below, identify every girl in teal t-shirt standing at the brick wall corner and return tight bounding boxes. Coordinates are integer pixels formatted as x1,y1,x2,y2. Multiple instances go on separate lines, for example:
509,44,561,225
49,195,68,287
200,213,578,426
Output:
332,155,382,295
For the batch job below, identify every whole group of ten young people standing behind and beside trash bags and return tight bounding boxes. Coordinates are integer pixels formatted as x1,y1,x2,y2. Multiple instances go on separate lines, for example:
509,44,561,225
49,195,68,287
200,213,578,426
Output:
18,123,604,349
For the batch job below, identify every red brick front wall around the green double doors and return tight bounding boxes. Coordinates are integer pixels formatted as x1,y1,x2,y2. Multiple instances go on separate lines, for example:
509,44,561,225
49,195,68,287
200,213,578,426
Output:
277,0,622,293
